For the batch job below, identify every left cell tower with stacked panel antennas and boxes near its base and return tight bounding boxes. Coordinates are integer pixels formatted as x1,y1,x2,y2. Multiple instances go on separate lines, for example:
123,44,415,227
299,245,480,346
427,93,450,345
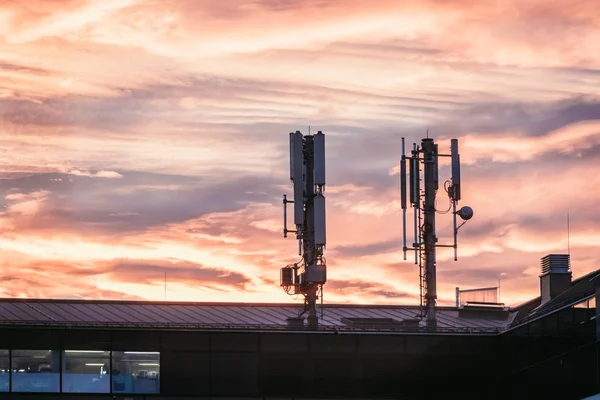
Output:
281,131,327,328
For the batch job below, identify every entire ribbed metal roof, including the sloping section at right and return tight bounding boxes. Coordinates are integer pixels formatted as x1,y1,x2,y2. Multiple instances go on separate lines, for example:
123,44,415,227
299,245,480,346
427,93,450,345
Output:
0,262,600,334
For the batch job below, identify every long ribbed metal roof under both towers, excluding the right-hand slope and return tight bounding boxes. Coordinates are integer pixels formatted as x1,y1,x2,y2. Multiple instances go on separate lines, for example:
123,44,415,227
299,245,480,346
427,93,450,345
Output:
0,298,510,334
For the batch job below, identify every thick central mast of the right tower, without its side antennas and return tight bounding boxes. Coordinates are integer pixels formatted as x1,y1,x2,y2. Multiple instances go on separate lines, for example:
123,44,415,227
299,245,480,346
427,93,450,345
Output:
421,138,437,329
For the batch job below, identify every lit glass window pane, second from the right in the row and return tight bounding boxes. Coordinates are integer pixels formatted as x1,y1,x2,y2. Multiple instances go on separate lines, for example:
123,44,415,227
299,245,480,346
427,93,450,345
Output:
62,350,110,393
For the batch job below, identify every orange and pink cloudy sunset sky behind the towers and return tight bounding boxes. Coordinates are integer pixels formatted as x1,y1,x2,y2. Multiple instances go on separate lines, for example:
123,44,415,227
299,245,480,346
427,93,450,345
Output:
0,0,600,304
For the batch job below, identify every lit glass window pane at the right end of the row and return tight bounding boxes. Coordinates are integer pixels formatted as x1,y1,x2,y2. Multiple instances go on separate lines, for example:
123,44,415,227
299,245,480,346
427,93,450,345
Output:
112,351,160,393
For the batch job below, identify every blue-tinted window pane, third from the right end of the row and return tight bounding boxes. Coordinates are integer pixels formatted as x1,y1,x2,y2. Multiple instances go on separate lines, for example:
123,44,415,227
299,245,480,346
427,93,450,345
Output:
11,350,60,392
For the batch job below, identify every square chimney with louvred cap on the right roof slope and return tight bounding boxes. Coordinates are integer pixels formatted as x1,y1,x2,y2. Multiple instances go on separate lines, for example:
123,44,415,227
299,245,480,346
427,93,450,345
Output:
540,254,571,304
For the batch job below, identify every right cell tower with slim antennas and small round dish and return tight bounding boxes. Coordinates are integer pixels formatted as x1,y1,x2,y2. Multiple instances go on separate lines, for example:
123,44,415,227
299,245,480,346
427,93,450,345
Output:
400,138,473,329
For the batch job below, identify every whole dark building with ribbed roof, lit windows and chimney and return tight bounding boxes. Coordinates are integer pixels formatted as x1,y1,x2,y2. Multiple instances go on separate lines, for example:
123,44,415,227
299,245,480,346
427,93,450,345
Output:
0,258,600,400
